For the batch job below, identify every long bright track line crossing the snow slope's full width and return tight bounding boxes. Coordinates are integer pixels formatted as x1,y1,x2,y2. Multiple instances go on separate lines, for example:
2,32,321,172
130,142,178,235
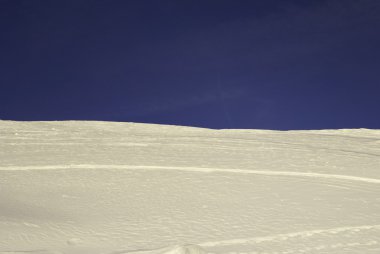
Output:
0,164,380,184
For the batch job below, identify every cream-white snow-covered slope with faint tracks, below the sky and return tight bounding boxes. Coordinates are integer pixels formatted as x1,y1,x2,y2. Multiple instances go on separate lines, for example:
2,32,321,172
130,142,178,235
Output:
0,121,380,254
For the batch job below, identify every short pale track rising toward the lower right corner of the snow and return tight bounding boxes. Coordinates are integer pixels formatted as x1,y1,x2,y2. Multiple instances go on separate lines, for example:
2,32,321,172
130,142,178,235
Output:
198,224,380,247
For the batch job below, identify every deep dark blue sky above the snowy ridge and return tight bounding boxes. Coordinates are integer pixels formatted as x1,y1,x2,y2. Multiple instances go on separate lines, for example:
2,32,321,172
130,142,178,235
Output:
0,0,380,130
